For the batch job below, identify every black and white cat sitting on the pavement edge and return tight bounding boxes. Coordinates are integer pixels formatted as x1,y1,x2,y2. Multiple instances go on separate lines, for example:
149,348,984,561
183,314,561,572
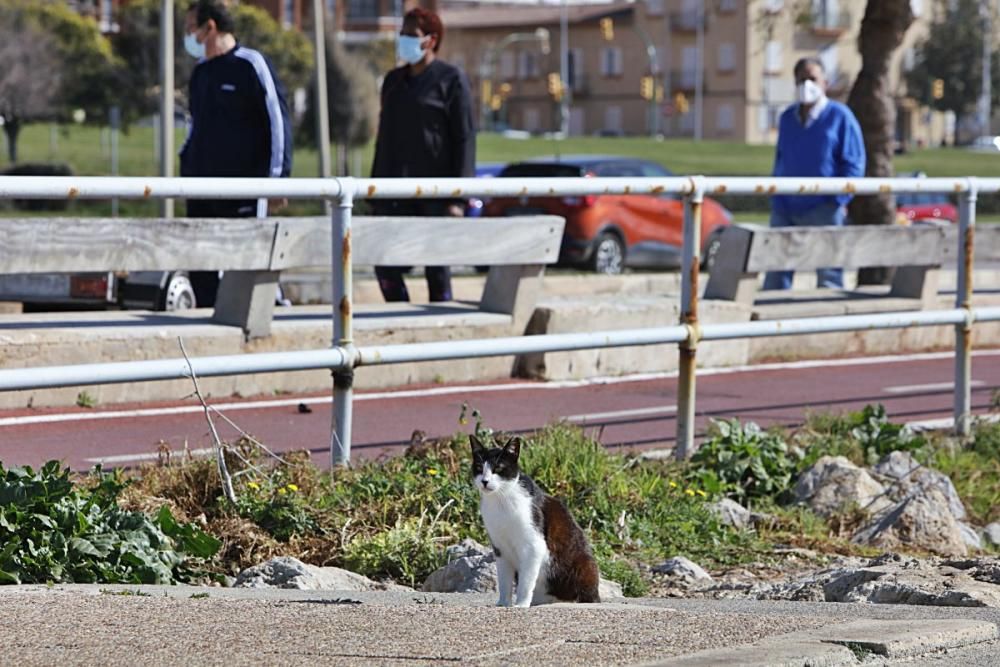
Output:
469,436,601,607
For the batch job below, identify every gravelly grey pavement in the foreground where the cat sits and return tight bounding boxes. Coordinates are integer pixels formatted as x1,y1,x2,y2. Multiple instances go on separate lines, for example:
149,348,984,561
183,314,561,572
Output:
0,585,1000,666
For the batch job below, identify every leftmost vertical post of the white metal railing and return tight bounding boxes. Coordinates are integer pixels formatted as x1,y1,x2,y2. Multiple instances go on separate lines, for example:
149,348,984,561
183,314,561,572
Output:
330,178,357,467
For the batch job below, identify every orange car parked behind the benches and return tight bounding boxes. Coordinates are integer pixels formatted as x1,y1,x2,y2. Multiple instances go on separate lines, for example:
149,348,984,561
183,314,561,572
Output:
484,155,732,273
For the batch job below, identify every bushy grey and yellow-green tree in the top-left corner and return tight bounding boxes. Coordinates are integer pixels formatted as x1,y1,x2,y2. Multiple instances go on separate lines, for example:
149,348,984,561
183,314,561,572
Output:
0,0,120,162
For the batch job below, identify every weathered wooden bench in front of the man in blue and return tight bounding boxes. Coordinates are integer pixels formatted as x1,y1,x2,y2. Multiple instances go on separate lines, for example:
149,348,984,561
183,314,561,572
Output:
704,225,1000,308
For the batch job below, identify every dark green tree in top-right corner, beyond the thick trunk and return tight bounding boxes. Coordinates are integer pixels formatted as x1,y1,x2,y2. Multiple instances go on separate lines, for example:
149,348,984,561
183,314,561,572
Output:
906,0,1000,138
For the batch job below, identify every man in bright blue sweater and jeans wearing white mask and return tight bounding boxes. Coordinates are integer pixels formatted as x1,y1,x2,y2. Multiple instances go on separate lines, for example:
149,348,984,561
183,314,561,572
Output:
764,58,865,289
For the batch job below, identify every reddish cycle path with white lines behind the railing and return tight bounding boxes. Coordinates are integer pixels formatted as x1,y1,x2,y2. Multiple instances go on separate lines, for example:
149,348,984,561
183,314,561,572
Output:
0,350,1000,469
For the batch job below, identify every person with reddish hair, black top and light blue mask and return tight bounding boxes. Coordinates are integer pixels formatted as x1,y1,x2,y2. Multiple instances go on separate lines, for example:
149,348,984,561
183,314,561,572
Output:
372,8,476,301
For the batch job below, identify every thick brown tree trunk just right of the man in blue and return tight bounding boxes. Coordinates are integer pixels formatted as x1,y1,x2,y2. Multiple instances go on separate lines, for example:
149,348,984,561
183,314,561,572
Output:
847,0,913,285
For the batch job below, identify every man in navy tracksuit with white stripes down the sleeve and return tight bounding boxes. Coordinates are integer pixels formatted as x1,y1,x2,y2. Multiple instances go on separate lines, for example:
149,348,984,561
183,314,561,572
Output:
181,0,292,307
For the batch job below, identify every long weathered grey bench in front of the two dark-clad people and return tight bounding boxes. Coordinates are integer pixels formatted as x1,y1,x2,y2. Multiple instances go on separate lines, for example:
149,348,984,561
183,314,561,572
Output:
0,216,565,338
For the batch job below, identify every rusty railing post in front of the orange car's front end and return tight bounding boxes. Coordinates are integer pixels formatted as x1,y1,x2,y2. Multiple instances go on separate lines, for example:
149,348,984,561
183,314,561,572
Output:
674,176,705,460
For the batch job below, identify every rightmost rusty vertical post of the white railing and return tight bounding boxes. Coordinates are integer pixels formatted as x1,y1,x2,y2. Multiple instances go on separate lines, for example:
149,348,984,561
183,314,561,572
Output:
955,178,979,435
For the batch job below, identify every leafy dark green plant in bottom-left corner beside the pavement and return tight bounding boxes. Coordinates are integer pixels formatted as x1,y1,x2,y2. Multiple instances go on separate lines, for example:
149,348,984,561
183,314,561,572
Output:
0,461,219,584
